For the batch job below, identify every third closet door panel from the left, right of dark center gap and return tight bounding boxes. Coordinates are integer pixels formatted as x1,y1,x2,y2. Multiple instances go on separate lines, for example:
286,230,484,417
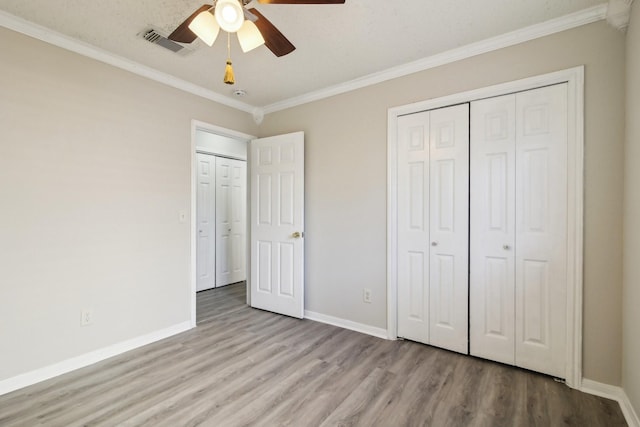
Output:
469,95,516,364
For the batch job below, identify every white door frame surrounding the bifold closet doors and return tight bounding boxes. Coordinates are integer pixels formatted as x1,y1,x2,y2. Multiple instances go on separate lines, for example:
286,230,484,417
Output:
387,66,584,388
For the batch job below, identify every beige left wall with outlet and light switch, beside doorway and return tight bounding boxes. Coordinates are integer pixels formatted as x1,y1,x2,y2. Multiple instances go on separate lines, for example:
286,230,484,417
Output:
0,28,257,380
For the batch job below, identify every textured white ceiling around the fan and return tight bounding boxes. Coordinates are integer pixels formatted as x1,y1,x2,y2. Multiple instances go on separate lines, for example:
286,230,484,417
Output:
0,0,602,107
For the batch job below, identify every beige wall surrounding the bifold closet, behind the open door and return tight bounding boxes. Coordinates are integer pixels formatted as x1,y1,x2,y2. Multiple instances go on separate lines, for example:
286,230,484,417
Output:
260,22,625,385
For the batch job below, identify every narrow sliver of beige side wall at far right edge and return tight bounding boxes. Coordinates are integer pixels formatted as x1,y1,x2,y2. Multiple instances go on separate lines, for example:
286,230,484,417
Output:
622,2,640,414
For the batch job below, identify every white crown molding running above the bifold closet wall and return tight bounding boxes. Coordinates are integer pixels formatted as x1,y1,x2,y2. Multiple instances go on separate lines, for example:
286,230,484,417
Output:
263,0,608,114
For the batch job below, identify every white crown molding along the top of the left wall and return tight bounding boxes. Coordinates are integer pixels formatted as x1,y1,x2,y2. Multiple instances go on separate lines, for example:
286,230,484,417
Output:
0,11,255,114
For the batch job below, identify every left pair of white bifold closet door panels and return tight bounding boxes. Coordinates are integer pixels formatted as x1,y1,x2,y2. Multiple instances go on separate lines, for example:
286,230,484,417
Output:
398,104,469,353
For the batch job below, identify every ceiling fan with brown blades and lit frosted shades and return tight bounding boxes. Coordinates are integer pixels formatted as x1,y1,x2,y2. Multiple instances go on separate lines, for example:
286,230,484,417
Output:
169,0,345,57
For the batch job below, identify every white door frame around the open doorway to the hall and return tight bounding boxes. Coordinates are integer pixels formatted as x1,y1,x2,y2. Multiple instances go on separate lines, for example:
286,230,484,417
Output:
188,119,256,328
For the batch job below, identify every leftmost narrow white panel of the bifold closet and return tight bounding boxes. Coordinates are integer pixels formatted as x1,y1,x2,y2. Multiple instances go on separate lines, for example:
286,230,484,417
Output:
398,112,429,343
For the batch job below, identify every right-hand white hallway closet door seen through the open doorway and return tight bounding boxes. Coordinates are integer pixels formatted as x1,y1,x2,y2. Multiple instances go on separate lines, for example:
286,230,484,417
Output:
216,157,247,286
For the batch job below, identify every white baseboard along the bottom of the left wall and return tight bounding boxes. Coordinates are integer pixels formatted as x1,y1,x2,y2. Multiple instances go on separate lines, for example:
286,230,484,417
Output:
0,321,192,396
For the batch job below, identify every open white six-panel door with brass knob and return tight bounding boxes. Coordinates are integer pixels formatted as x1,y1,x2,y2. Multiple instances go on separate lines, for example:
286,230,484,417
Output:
249,132,304,318
